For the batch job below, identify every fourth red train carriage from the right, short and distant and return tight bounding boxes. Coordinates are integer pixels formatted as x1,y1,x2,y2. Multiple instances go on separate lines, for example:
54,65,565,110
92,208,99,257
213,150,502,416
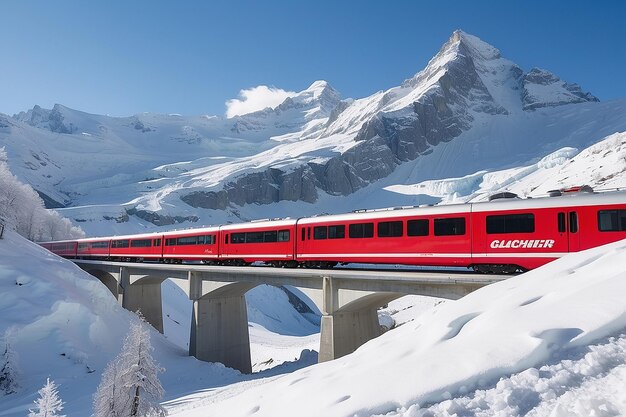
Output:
163,226,219,263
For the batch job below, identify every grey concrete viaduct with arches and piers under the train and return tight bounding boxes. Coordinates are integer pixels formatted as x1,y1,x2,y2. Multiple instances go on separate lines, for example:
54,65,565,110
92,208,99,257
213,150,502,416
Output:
74,260,509,373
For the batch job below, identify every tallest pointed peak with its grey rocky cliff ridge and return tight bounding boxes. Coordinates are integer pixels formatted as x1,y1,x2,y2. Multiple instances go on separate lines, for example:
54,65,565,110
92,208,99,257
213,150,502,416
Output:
182,31,597,209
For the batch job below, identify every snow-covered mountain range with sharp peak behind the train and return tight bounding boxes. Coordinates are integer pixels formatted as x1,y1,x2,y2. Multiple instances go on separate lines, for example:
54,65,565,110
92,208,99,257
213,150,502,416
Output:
0,31,626,234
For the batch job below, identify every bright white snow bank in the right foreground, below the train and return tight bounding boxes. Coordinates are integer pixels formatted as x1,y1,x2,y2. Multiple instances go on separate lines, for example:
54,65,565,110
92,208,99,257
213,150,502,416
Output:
171,237,626,417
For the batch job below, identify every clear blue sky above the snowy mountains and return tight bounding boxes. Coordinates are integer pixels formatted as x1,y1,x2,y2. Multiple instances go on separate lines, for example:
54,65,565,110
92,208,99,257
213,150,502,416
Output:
0,0,626,116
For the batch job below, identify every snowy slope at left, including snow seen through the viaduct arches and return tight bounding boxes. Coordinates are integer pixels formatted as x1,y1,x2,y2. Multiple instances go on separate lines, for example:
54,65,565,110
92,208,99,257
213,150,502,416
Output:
0,231,319,417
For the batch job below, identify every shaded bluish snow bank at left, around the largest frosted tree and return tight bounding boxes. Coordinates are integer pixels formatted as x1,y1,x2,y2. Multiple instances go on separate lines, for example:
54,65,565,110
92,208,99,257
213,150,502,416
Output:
0,231,242,417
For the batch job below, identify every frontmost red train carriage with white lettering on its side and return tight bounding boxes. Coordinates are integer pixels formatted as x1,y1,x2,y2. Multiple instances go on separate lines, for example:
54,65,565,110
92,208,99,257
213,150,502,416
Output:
472,192,626,272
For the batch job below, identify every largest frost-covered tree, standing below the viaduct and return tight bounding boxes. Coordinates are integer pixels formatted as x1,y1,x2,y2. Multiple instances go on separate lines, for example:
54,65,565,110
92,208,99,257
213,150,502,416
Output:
93,316,166,417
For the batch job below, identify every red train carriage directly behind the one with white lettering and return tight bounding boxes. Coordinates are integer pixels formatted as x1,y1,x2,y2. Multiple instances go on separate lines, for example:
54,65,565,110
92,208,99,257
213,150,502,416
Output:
296,204,471,267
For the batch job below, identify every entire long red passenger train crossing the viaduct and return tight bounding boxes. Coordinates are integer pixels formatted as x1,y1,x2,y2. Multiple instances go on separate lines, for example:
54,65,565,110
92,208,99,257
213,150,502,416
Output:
41,191,626,273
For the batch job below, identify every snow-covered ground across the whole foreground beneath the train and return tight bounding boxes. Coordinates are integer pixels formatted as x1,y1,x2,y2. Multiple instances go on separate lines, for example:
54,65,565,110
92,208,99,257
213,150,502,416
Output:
0,232,626,417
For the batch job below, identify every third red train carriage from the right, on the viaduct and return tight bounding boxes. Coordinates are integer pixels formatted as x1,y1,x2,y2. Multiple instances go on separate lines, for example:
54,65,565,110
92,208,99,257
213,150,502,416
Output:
220,219,297,266
